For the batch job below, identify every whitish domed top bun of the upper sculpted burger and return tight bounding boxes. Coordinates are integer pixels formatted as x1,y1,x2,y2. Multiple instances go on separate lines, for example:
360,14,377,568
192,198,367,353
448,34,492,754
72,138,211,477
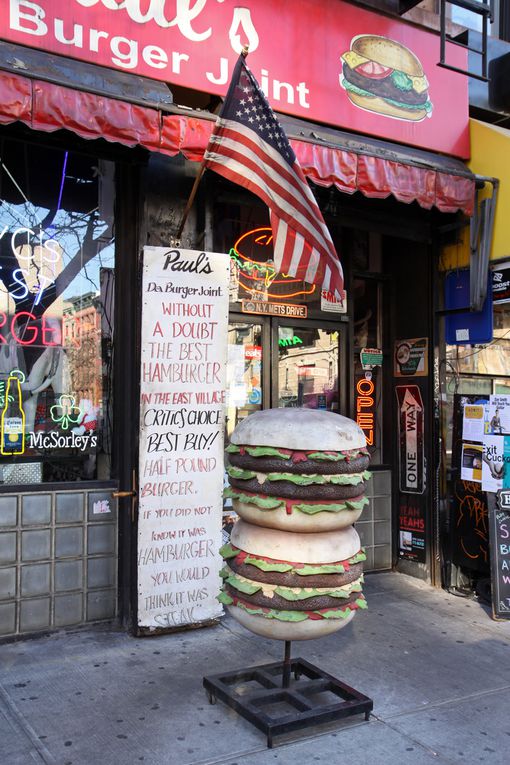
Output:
230,408,366,452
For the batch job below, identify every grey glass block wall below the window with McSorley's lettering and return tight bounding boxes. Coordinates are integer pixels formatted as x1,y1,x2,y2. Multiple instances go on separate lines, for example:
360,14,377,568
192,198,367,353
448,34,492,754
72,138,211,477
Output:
0,489,117,639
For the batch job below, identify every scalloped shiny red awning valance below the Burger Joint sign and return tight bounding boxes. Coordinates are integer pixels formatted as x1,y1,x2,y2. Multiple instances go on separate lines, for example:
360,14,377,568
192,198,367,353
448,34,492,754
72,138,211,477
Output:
0,72,475,215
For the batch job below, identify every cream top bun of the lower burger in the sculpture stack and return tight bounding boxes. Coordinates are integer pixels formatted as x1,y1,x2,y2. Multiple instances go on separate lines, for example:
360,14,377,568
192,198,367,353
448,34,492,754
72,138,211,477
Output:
230,520,361,563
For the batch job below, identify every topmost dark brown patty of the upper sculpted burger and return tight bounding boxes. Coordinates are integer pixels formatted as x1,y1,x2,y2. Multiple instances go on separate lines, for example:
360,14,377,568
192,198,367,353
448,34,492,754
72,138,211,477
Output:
227,449,370,475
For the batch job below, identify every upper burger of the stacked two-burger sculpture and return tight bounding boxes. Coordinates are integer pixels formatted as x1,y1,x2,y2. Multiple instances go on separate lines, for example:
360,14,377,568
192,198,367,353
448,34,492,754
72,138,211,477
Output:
225,408,370,532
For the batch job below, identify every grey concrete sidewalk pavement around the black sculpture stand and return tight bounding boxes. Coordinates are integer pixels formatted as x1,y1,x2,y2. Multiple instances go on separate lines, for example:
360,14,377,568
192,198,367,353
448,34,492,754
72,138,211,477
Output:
0,573,510,765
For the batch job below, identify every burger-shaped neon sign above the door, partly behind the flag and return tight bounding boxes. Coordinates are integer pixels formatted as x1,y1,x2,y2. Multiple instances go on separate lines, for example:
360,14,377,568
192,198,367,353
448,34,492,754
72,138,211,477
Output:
230,226,316,300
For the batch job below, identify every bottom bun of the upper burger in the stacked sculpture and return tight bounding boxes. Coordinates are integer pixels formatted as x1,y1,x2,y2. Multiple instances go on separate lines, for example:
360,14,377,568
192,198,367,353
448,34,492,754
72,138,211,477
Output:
232,499,363,533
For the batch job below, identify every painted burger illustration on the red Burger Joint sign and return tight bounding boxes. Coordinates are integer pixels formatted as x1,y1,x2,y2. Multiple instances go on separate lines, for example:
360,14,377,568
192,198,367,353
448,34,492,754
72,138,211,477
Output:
340,35,432,122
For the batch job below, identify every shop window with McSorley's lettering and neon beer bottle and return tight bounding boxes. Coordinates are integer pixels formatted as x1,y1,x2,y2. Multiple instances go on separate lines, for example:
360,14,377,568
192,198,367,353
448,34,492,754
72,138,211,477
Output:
0,140,114,485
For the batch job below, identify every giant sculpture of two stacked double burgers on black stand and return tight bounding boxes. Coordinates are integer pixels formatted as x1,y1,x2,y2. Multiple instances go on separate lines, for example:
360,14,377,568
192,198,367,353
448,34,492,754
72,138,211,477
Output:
219,408,370,641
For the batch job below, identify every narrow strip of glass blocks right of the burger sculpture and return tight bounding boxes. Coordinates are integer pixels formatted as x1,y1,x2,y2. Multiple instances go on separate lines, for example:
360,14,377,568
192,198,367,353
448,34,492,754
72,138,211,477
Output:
355,470,392,571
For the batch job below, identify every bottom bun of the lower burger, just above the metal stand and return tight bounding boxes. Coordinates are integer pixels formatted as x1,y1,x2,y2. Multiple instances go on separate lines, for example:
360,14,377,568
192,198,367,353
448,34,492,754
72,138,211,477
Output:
225,606,356,640
